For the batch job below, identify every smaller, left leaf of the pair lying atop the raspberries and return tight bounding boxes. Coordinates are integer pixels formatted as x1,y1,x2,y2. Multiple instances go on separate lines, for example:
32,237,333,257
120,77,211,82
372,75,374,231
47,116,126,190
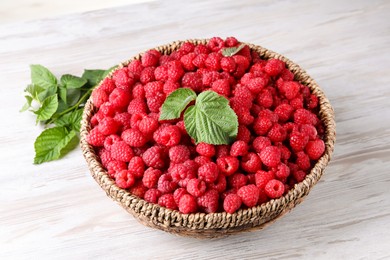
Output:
160,88,196,120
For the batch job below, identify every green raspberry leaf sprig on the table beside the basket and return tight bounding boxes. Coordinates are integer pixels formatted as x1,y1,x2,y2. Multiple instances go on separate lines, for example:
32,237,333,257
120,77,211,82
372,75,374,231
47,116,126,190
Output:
20,65,113,164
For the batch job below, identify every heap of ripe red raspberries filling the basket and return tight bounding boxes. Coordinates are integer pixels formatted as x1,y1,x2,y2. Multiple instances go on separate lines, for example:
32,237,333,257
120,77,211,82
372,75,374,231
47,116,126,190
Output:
87,37,325,214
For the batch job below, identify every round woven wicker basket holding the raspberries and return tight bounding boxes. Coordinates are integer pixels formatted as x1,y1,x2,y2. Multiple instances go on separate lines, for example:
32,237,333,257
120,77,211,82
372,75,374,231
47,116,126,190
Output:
81,39,336,238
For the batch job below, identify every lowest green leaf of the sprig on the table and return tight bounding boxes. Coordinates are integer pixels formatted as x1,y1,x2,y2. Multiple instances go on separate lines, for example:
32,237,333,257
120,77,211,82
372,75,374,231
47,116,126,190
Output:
34,127,77,164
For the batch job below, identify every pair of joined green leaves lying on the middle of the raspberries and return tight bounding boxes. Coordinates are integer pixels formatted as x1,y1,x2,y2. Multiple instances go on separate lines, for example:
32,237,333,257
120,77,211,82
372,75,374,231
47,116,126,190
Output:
160,88,238,145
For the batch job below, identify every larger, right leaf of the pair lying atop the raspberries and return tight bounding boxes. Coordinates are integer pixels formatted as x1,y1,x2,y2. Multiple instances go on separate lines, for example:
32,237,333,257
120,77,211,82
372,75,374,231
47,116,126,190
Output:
184,90,238,145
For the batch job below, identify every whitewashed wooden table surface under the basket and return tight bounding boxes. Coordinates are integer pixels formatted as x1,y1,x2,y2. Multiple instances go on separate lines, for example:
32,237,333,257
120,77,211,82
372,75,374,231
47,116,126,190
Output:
0,0,390,259
